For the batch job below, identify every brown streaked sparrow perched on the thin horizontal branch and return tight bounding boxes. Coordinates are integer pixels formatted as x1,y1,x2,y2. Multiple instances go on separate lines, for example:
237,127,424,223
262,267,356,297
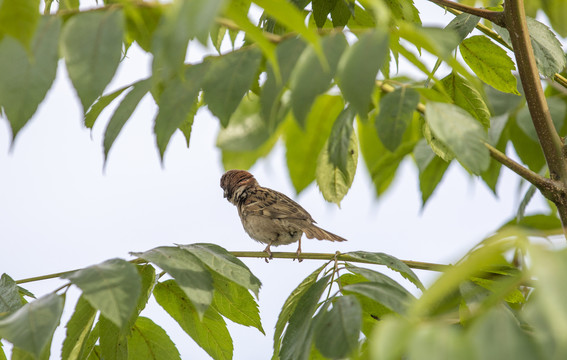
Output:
220,170,346,262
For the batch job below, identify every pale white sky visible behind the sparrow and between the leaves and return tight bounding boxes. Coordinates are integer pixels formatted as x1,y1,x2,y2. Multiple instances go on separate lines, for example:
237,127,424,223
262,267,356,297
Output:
0,1,556,359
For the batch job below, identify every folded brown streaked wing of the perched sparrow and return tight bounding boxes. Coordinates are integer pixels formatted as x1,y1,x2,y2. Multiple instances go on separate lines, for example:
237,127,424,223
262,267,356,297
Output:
242,187,315,223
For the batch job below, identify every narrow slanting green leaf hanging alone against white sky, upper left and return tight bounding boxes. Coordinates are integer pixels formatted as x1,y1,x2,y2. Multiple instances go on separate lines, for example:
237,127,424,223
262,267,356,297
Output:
104,79,152,162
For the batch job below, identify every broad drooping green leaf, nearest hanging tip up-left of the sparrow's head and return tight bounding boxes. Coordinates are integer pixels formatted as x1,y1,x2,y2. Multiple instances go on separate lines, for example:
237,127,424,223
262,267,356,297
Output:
154,63,208,160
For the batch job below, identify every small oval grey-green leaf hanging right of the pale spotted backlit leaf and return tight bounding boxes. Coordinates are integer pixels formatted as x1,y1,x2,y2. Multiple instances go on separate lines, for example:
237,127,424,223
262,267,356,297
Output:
374,86,419,152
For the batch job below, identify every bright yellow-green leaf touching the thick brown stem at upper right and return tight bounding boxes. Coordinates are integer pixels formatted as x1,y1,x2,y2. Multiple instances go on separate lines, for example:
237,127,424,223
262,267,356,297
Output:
459,35,520,95
